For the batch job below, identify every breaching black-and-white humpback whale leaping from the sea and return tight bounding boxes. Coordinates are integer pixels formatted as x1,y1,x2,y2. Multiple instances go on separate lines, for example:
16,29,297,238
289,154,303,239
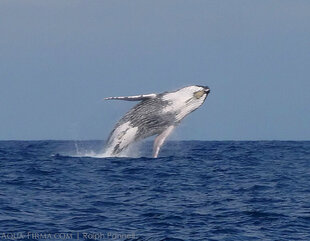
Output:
104,85,210,158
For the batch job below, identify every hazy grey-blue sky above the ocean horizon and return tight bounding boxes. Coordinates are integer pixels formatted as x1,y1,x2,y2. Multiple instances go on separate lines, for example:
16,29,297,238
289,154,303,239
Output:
0,0,310,140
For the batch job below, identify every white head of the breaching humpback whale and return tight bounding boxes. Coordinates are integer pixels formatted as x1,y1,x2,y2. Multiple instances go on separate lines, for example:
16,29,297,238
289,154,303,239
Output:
162,85,210,121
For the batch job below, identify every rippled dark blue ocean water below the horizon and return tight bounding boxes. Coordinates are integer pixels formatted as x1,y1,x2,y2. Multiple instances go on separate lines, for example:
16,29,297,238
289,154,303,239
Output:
0,141,310,240
